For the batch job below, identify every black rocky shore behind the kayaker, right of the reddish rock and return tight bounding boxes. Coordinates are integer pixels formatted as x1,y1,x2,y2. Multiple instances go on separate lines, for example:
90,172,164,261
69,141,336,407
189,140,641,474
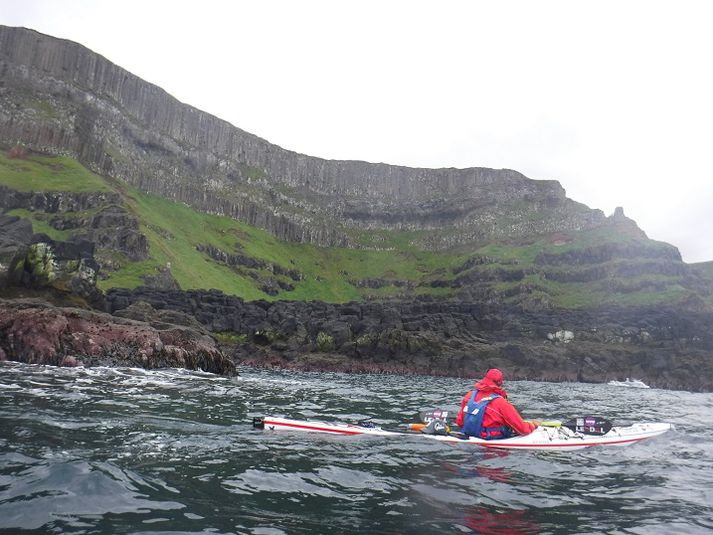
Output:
107,289,713,391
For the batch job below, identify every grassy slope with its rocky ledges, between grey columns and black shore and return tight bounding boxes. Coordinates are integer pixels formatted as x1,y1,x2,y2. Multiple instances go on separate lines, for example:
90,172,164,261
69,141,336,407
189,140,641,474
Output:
0,152,713,308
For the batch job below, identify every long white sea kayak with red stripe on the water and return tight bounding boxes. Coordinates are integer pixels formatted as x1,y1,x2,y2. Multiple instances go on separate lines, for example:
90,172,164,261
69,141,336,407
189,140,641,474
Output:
253,417,671,451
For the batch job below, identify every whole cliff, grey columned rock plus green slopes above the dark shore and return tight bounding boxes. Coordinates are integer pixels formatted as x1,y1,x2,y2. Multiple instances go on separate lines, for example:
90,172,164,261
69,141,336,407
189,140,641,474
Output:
0,26,713,310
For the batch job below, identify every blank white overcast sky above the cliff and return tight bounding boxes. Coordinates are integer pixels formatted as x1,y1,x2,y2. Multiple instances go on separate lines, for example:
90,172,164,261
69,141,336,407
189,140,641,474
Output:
0,0,713,262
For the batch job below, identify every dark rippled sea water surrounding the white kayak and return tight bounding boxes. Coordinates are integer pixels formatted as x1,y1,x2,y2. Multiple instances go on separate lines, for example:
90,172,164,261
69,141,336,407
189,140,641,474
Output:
0,362,713,535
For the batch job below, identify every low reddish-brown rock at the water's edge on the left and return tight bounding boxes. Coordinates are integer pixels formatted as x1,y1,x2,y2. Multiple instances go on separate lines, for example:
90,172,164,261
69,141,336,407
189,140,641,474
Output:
0,300,235,375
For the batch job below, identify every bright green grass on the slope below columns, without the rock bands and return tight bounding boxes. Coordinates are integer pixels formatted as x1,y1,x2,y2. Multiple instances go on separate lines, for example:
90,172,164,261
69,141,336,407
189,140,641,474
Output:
0,154,700,306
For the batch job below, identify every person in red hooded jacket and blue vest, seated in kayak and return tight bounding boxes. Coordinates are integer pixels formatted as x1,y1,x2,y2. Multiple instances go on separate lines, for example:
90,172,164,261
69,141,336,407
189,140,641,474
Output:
456,368,541,440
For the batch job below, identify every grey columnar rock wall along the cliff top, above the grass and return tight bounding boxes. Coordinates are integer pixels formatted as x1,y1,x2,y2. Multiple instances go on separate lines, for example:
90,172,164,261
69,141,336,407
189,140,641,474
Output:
0,26,606,249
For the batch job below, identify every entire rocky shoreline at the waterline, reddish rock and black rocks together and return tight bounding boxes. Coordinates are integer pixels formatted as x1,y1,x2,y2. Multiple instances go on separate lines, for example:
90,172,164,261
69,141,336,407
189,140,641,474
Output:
0,288,713,392
